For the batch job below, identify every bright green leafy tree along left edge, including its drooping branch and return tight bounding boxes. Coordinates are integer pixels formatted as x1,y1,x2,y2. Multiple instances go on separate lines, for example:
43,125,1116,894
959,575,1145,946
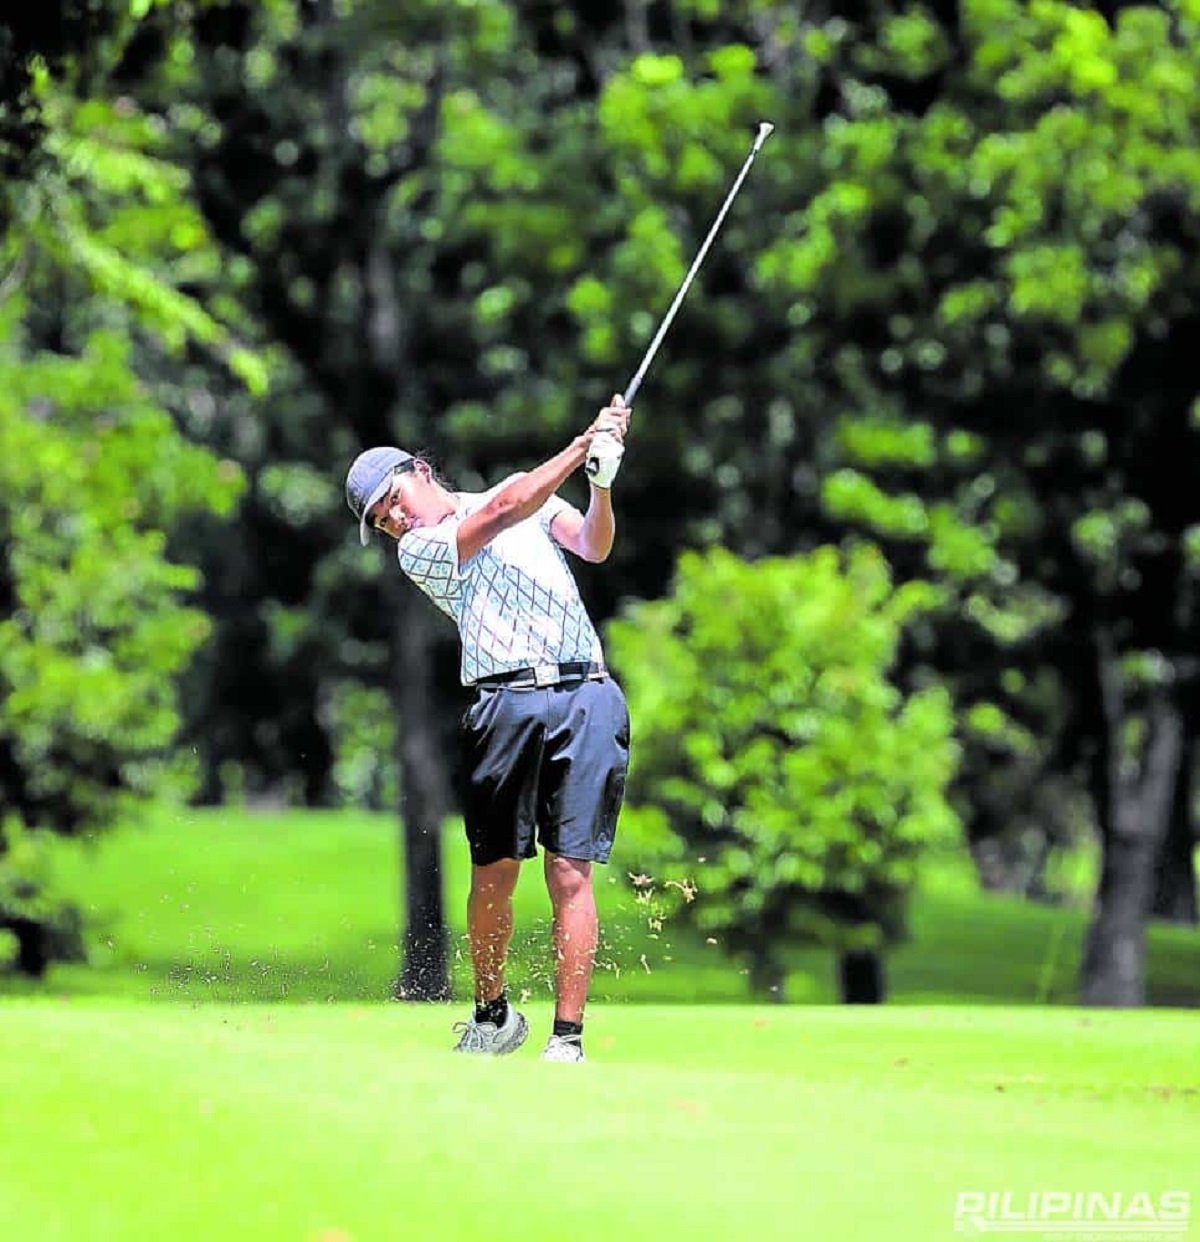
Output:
0,14,250,974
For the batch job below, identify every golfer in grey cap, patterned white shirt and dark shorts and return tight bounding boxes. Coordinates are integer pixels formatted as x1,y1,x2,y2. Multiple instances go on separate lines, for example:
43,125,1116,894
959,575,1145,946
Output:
345,396,630,1062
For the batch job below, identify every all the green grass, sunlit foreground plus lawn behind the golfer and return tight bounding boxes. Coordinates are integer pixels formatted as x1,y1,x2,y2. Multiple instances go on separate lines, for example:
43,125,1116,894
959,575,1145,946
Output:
9,811,1200,1242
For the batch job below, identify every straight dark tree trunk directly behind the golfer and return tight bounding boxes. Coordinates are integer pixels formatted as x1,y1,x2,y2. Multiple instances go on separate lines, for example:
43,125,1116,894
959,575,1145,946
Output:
389,586,451,1001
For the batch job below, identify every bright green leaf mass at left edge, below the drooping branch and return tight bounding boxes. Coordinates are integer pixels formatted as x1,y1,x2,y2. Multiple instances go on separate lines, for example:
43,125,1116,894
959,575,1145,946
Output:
0,301,239,832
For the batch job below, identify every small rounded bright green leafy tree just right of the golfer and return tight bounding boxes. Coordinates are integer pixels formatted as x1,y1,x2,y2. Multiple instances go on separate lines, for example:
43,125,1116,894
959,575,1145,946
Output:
607,546,957,981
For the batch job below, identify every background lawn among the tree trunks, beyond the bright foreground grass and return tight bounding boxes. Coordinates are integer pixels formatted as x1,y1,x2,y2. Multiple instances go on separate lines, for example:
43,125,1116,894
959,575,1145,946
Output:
16,810,1200,1007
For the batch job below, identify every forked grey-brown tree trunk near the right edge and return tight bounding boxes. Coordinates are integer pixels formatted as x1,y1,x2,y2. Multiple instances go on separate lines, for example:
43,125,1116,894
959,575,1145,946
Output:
1081,633,1183,1007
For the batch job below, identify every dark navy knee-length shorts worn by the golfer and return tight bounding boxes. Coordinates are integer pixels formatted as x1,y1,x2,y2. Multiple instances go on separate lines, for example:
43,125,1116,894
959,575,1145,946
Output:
461,677,629,866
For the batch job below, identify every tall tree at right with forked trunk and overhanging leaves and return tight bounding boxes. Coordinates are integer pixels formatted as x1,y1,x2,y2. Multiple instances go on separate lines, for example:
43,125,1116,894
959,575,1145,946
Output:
763,0,1200,1005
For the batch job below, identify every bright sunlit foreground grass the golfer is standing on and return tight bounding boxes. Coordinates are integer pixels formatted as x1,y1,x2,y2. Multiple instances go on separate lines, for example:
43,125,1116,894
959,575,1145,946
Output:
0,997,1200,1242
